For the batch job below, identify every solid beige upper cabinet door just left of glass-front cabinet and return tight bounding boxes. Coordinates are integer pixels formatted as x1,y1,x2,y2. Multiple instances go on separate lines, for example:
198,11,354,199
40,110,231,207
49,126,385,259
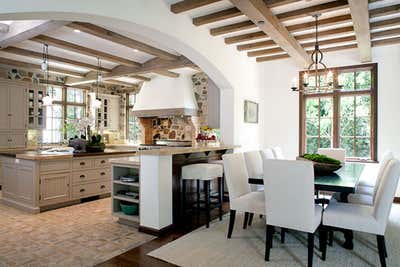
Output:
10,86,27,130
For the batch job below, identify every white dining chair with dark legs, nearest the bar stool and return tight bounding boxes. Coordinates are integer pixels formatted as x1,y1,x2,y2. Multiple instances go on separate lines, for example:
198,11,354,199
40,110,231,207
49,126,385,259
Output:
222,153,265,238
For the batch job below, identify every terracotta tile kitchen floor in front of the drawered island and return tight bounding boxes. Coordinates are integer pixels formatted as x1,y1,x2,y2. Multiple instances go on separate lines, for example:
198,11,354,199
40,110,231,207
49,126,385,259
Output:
0,198,154,267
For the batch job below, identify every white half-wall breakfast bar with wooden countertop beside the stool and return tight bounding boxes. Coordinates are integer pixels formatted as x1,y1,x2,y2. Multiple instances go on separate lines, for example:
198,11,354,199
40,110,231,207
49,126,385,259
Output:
127,144,235,235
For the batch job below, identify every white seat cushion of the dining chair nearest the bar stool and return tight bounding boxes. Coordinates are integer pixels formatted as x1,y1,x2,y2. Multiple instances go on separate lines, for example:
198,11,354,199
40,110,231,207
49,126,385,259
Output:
229,191,265,215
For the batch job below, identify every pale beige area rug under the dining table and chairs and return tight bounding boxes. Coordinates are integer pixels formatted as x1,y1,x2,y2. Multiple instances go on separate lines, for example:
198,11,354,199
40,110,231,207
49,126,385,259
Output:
148,205,400,267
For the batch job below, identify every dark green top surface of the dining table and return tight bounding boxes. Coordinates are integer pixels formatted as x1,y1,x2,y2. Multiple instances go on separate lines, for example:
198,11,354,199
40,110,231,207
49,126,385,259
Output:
249,162,365,193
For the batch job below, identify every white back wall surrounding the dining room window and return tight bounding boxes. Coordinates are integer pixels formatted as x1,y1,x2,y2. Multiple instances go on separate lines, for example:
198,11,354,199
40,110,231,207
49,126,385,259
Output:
258,45,400,196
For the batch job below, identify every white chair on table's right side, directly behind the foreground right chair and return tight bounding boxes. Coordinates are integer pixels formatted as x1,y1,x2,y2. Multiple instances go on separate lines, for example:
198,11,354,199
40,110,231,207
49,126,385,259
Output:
348,152,394,206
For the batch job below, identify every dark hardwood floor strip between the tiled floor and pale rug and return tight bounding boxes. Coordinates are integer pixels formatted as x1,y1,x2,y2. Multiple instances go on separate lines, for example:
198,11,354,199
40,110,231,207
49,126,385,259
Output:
97,202,229,267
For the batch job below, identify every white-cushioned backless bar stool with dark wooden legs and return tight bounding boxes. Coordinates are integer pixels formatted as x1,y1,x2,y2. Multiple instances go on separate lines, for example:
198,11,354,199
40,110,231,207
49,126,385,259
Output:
182,163,223,228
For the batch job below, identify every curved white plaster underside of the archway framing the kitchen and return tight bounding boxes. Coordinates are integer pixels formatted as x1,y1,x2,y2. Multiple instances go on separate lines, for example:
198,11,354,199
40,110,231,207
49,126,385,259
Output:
0,0,244,144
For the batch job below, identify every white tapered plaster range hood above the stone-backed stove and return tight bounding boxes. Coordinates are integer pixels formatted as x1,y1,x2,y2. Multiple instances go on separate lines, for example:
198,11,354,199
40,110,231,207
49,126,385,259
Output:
134,74,198,110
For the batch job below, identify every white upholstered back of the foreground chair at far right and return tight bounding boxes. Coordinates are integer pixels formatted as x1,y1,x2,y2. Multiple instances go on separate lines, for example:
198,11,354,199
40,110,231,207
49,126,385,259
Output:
373,159,400,234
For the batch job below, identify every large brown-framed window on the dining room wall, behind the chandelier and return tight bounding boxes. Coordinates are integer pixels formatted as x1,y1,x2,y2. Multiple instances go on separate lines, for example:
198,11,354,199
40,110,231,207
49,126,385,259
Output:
300,64,377,160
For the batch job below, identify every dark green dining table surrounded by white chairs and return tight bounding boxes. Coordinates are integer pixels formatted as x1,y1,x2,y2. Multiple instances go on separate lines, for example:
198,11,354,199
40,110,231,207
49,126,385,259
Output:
248,162,365,249
